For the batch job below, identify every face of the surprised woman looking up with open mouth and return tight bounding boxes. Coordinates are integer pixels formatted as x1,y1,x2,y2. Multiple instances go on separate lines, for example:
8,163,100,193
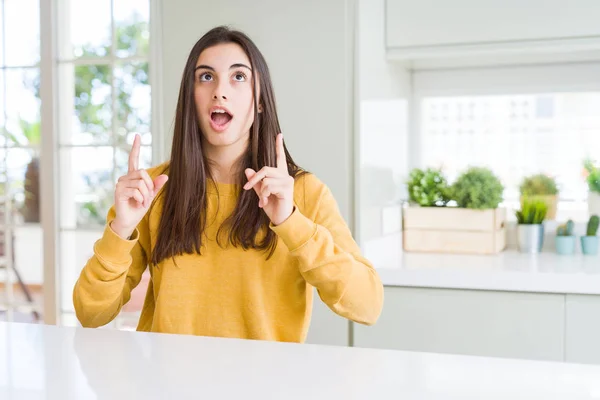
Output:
194,43,258,147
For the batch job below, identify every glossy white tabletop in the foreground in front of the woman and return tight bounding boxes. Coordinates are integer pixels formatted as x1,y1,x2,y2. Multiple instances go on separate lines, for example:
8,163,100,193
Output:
0,323,600,400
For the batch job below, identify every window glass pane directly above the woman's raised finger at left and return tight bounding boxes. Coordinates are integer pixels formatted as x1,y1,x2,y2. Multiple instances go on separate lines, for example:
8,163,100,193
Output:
114,63,152,146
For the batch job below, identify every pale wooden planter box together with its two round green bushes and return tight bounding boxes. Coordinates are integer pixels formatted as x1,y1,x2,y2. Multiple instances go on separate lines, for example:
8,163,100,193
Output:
402,167,506,254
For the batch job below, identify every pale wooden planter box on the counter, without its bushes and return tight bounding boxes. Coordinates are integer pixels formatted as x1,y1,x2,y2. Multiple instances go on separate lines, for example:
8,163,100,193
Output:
403,207,506,254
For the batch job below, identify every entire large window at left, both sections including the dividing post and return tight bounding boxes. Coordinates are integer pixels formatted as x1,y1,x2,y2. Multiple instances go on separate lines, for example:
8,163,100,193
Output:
0,0,153,329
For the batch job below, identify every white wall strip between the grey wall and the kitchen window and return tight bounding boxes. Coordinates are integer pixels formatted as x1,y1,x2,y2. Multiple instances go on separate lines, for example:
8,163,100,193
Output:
356,0,411,267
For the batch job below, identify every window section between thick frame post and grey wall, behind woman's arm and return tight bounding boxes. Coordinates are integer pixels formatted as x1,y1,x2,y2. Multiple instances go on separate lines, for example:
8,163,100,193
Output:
57,0,152,325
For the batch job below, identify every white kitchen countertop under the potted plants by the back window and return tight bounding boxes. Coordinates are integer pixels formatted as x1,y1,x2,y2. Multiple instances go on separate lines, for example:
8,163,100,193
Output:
365,237,600,295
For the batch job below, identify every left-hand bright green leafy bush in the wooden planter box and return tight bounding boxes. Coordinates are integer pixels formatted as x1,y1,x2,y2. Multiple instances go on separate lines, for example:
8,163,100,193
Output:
407,168,448,207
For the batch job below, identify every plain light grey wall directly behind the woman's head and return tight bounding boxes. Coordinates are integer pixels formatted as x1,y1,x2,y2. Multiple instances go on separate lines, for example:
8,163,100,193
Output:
160,0,354,224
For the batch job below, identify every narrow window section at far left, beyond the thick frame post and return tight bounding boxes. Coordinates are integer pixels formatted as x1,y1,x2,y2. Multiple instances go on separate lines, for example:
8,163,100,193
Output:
0,0,43,321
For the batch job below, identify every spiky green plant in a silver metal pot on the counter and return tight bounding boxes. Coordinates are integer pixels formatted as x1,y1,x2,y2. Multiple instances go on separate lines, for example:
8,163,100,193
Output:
515,199,548,253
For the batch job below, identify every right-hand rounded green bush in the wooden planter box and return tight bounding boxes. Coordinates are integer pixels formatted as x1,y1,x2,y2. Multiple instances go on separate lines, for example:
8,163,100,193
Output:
450,167,504,210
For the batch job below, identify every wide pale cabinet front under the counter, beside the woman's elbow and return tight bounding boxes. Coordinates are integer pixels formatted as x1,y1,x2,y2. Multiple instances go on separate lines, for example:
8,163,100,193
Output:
354,287,565,361
